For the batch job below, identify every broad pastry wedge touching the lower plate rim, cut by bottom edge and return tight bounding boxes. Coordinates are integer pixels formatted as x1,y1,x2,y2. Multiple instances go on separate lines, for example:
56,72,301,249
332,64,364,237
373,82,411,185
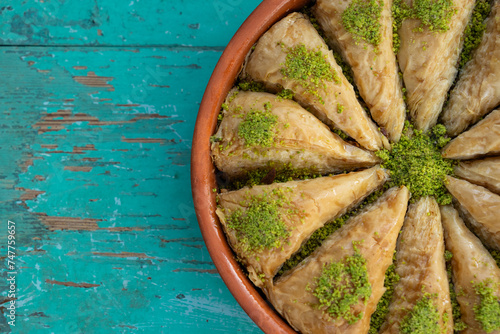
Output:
268,187,409,334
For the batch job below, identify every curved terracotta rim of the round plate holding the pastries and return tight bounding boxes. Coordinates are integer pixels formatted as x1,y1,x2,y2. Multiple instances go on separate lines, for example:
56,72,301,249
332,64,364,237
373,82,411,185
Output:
191,0,310,334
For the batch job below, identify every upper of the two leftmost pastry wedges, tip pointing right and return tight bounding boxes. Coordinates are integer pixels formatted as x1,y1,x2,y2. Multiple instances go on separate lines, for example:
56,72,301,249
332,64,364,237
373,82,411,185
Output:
212,91,378,177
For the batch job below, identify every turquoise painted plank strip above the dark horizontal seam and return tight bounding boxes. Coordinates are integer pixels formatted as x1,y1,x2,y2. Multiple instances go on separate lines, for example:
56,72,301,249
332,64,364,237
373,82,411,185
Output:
0,0,260,47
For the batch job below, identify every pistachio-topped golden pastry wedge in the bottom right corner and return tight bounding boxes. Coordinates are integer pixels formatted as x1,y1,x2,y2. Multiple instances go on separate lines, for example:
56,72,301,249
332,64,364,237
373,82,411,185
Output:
441,206,500,334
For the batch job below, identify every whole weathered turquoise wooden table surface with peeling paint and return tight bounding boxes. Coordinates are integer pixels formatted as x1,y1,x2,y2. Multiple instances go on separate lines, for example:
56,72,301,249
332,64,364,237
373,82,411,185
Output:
0,0,261,333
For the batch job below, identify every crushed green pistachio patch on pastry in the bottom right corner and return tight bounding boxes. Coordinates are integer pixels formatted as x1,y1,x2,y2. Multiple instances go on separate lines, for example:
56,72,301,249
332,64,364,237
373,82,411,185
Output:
474,279,500,333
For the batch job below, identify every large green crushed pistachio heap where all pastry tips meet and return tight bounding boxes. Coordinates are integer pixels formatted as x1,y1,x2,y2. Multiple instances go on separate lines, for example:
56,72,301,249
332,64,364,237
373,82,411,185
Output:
375,121,454,205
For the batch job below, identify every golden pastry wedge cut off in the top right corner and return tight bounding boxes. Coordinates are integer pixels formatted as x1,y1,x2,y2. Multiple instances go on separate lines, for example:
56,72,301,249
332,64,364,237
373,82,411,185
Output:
442,0,500,136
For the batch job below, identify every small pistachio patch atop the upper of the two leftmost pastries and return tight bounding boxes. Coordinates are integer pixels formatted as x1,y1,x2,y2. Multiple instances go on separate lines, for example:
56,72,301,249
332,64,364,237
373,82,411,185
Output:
238,104,278,147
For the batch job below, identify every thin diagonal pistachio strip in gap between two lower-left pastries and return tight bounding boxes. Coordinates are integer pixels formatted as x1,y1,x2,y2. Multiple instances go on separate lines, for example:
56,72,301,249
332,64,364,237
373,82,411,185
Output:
277,189,384,277
